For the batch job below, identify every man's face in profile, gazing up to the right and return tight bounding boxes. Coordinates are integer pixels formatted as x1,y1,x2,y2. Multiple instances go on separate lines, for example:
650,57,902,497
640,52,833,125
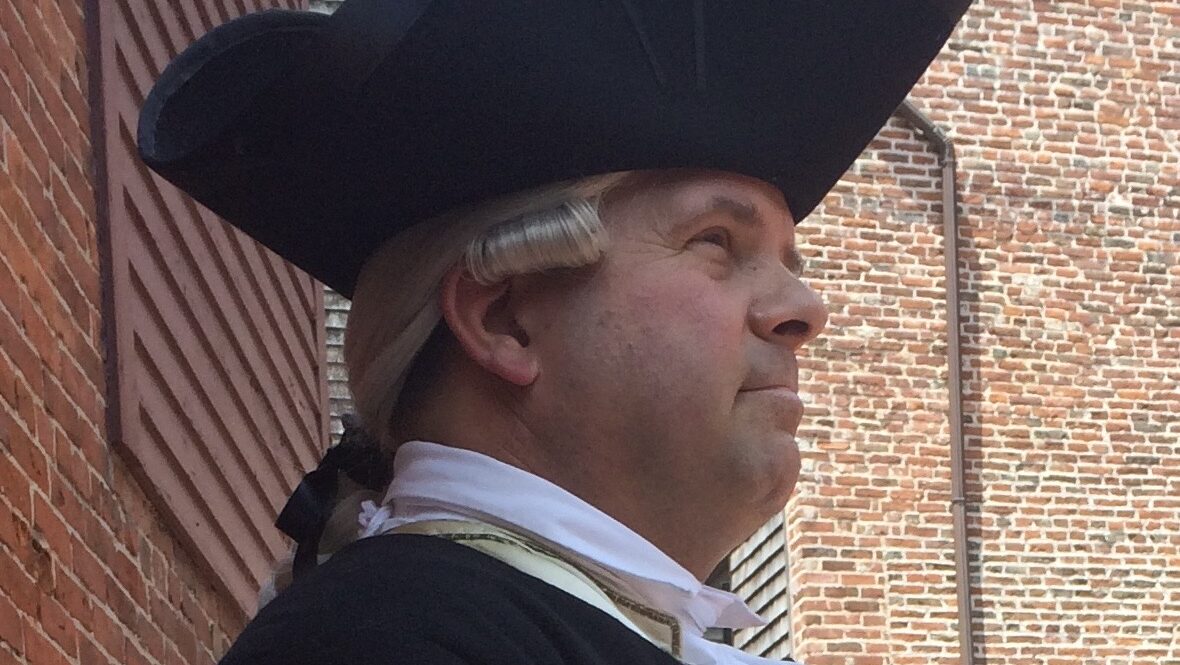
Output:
516,171,826,544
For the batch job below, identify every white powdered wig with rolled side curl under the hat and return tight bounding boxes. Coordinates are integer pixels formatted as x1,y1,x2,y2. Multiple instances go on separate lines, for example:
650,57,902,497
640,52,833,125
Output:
345,173,624,449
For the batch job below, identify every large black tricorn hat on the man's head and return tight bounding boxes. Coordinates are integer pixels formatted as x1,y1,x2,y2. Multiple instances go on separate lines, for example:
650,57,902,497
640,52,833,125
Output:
139,0,970,296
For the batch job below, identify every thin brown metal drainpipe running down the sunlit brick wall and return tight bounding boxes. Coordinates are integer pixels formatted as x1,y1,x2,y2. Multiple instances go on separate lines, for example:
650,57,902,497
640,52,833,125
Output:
898,100,975,665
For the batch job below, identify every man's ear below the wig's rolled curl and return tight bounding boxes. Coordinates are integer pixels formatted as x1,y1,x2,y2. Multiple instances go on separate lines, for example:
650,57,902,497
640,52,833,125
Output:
439,265,540,387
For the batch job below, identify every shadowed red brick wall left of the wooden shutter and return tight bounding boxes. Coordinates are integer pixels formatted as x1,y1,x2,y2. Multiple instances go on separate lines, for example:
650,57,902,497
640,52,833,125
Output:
0,0,244,665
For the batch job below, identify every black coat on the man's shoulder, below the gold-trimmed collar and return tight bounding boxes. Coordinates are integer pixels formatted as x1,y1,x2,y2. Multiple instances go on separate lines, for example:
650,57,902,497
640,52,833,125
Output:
221,534,677,665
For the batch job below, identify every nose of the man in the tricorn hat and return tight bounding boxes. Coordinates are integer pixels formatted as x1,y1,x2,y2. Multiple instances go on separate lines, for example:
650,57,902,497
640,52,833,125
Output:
750,270,827,350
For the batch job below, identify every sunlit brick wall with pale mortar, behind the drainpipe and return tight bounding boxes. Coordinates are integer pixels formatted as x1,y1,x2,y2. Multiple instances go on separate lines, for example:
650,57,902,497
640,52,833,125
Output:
787,0,1180,665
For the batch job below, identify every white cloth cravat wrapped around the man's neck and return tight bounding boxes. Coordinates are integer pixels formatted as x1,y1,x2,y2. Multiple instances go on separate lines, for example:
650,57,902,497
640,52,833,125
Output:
349,441,779,665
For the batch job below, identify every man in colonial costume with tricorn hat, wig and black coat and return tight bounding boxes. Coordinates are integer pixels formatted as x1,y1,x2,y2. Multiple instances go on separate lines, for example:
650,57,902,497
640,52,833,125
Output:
140,0,966,664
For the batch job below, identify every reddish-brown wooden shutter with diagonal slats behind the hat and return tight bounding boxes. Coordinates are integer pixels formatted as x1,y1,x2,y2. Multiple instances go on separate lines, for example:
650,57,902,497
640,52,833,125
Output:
96,0,328,613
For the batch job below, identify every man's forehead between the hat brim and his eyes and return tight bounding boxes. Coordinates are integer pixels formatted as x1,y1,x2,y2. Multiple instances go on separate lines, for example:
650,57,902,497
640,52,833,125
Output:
603,170,794,236
